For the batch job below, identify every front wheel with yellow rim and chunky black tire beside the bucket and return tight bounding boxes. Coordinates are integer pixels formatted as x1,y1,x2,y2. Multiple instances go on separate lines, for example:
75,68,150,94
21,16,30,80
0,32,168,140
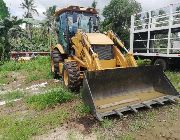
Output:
62,62,81,92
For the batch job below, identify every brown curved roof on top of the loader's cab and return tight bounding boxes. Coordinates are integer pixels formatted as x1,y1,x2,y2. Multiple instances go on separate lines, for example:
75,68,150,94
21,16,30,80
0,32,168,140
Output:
55,6,98,16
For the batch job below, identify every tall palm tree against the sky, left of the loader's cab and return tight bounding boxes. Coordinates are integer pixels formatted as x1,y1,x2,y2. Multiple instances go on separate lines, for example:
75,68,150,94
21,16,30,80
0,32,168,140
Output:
20,0,38,39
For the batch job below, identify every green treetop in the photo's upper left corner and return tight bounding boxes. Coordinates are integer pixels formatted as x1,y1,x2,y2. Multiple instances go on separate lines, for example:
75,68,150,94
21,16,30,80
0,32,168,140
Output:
0,0,9,19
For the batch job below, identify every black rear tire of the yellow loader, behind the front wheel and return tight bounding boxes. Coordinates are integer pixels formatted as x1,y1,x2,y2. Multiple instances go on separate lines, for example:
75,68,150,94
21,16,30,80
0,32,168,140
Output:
52,48,63,79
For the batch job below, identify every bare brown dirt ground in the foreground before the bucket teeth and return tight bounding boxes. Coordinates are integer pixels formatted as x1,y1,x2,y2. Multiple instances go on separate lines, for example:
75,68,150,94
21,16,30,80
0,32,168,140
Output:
33,105,180,140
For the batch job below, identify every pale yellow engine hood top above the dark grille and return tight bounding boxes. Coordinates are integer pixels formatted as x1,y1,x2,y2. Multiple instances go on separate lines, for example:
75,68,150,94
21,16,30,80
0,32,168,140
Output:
86,33,114,45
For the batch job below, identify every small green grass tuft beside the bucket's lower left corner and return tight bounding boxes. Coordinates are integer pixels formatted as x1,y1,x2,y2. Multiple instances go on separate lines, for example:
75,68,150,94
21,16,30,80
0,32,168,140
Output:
75,103,91,116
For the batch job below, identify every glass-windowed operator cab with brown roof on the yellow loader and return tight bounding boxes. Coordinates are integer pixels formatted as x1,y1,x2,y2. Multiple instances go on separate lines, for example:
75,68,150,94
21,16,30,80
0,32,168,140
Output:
55,6,99,54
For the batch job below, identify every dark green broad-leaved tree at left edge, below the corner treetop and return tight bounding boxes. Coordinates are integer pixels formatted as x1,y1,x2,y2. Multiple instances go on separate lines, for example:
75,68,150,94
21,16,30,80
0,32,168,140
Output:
0,17,23,61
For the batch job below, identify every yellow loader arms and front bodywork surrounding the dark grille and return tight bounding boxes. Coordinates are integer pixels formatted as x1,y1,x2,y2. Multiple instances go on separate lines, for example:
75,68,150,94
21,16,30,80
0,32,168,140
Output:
71,30,137,71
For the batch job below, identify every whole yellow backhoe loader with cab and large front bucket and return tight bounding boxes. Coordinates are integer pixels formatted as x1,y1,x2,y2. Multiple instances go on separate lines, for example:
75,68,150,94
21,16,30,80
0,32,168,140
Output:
51,6,179,120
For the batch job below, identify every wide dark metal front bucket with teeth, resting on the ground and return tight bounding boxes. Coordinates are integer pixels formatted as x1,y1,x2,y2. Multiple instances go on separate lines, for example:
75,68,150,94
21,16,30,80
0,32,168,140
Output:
82,66,179,121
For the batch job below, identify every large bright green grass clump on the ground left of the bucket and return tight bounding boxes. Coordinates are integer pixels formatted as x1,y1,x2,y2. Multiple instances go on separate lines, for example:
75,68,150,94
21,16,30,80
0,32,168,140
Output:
26,88,73,110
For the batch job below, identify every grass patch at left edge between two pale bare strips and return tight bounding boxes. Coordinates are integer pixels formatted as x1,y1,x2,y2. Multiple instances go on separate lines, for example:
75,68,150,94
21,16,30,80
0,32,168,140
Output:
0,90,25,102
